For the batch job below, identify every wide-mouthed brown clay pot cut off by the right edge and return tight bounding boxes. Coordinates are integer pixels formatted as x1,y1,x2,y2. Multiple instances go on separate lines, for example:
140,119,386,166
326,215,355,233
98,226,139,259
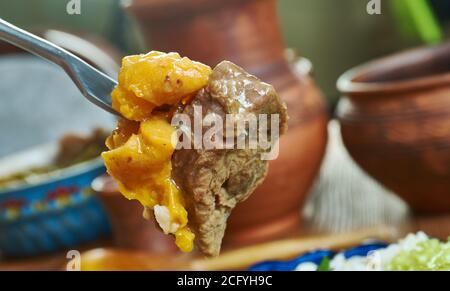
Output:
338,43,450,213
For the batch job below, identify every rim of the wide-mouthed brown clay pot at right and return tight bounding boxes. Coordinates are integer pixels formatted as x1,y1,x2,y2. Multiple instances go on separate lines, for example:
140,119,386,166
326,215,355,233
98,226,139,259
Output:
337,42,450,96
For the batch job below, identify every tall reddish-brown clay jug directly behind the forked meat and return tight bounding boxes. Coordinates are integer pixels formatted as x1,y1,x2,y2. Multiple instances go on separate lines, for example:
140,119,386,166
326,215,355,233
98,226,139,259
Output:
123,0,327,246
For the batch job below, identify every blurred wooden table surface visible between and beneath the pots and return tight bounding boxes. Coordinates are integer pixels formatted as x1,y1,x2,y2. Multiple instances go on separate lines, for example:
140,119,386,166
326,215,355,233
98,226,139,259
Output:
0,121,450,270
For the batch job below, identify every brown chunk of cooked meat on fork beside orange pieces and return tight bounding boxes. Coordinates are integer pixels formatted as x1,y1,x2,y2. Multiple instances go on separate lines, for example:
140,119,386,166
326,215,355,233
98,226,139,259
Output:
172,61,288,256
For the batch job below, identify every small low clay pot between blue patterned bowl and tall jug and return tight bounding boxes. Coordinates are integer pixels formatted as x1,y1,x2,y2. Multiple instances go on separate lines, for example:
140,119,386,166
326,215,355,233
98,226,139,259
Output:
92,175,177,253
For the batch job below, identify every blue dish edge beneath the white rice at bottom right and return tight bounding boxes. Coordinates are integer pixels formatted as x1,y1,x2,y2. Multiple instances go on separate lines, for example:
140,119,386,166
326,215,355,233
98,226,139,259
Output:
249,243,387,271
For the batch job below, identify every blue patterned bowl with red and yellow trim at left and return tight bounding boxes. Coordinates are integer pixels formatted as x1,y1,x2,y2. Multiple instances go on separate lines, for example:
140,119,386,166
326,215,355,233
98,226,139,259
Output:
0,145,110,257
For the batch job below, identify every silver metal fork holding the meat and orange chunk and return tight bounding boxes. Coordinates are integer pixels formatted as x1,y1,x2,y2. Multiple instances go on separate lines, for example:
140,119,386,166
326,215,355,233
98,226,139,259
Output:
0,18,120,116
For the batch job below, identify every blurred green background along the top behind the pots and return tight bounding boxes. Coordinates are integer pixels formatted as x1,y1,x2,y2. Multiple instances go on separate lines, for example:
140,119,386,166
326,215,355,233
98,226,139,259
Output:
0,0,450,104
